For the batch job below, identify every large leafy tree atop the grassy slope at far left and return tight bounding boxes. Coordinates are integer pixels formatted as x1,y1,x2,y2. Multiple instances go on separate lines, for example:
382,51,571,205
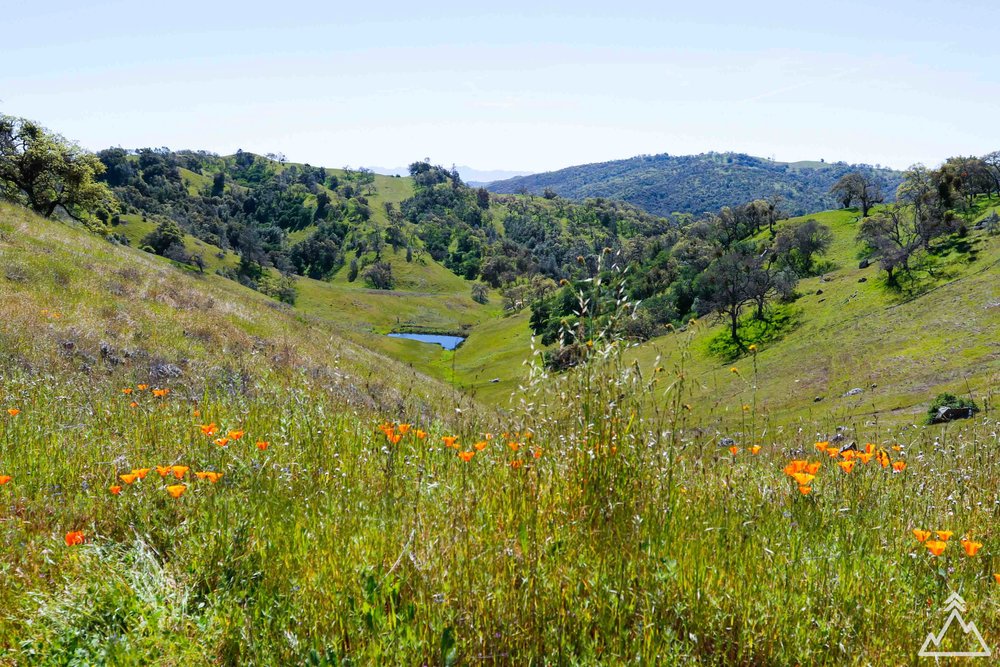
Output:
0,114,117,221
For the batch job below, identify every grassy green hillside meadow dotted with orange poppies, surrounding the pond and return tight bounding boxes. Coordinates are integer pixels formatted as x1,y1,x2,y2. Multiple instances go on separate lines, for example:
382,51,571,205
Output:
0,198,1000,665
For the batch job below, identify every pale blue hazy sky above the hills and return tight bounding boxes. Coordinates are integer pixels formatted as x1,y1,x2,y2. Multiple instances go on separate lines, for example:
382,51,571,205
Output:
0,0,1000,171
